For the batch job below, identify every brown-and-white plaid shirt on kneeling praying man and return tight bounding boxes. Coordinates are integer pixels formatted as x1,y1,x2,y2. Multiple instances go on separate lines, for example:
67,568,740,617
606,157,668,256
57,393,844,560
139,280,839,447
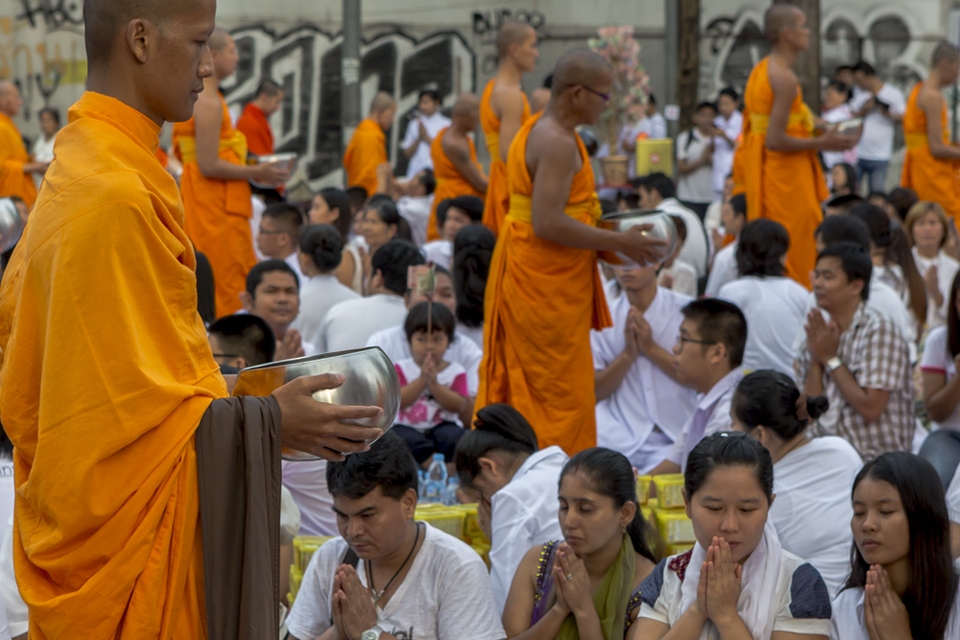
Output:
794,303,916,460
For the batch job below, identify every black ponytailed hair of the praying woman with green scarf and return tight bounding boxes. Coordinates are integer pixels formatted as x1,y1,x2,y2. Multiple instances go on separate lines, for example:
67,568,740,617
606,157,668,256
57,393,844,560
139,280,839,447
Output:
560,447,663,563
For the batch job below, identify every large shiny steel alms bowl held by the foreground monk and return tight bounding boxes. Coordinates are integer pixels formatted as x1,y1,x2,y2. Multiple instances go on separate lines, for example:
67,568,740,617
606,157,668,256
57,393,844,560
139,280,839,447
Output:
233,347,400,460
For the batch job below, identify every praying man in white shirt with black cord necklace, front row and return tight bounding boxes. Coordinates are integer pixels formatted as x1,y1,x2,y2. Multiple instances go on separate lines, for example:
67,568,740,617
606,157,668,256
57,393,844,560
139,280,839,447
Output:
287,433,506,640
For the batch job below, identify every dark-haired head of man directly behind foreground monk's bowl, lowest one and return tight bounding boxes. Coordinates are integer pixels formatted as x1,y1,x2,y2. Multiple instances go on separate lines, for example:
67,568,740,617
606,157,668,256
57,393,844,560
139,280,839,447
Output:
207,313,277,370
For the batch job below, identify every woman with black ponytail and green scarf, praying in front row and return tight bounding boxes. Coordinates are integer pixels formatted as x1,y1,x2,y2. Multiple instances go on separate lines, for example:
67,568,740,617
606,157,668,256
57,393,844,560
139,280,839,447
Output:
503,448,661,640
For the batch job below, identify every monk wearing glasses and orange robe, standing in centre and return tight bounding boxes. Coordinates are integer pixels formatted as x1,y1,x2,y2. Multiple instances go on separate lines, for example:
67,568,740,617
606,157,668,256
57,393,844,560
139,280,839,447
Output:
476,50,663,455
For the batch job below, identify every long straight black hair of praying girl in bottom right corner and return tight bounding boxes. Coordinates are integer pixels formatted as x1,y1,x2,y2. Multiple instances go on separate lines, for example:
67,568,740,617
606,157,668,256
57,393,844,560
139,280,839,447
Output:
843,451,958,640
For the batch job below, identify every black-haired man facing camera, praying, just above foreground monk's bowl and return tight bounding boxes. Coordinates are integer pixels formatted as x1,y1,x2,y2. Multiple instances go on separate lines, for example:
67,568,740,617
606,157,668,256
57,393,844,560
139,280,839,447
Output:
240,260,318,361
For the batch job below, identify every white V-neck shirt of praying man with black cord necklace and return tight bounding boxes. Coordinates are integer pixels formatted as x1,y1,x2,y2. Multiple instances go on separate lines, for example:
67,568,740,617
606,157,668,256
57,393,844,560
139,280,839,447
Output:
287,523,507,640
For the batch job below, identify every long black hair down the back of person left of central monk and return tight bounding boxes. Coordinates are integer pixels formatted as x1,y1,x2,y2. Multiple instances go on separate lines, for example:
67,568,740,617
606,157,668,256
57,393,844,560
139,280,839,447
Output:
453,224,497,328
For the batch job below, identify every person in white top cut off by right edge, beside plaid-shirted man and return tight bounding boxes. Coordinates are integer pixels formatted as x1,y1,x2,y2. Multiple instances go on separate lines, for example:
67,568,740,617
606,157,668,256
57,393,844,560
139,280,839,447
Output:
920,274,960,431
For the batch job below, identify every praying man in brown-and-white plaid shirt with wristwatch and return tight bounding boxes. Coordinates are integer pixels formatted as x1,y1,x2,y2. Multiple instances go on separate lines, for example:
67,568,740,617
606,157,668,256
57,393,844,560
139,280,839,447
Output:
794,242,915,460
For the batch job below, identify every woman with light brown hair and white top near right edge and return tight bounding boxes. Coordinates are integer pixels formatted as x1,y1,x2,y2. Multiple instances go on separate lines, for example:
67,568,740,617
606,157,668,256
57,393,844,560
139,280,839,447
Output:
903,202,960,329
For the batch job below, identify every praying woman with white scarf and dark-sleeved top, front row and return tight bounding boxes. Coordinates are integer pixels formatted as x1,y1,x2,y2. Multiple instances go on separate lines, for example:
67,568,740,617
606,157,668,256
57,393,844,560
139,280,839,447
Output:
627,432,830,640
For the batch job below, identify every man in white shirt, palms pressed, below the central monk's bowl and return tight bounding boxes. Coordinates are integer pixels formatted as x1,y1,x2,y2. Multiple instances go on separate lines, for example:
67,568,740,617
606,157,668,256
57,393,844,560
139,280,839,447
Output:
590,267,697,474
